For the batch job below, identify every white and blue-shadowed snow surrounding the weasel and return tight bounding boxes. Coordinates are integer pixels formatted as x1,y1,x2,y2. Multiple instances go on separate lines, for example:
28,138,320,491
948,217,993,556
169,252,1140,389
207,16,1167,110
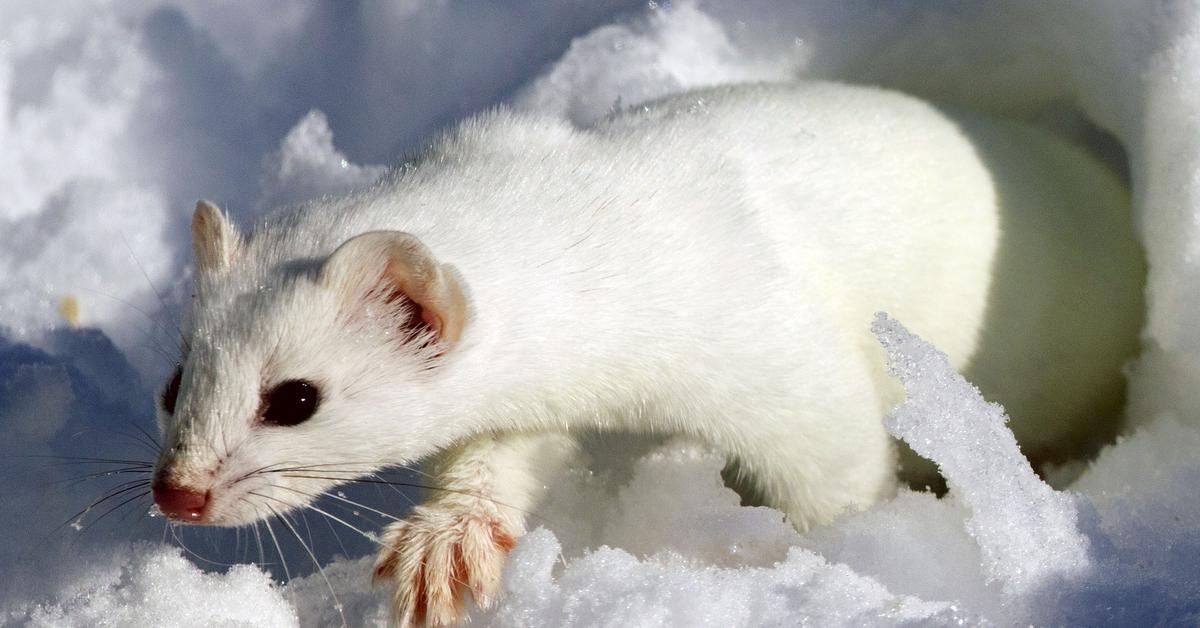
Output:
0,0,1200,626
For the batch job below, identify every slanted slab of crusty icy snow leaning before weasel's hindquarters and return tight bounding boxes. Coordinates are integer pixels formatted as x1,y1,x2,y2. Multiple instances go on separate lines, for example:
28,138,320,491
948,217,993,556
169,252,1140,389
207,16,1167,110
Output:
871,313,1090,594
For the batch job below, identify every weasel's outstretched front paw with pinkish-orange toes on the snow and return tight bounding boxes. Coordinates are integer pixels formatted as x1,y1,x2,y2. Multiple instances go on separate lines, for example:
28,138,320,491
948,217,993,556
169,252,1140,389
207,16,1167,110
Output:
374,504,520,627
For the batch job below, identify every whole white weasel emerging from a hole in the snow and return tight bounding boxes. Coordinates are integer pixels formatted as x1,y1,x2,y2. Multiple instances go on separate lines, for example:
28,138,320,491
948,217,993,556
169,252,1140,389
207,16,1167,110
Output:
154,83,1140,624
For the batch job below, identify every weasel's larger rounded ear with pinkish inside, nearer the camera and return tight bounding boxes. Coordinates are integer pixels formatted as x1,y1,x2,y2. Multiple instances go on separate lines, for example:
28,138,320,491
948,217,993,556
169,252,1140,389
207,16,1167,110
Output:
320,231,467,347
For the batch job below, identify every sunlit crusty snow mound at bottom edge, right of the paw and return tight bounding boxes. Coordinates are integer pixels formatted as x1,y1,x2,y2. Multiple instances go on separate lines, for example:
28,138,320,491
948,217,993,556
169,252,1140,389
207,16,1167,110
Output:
485,530,985,627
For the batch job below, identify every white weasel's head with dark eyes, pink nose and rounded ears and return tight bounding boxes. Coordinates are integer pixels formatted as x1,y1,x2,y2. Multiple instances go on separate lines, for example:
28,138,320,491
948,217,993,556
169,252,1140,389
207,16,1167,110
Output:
152,202,468,525
